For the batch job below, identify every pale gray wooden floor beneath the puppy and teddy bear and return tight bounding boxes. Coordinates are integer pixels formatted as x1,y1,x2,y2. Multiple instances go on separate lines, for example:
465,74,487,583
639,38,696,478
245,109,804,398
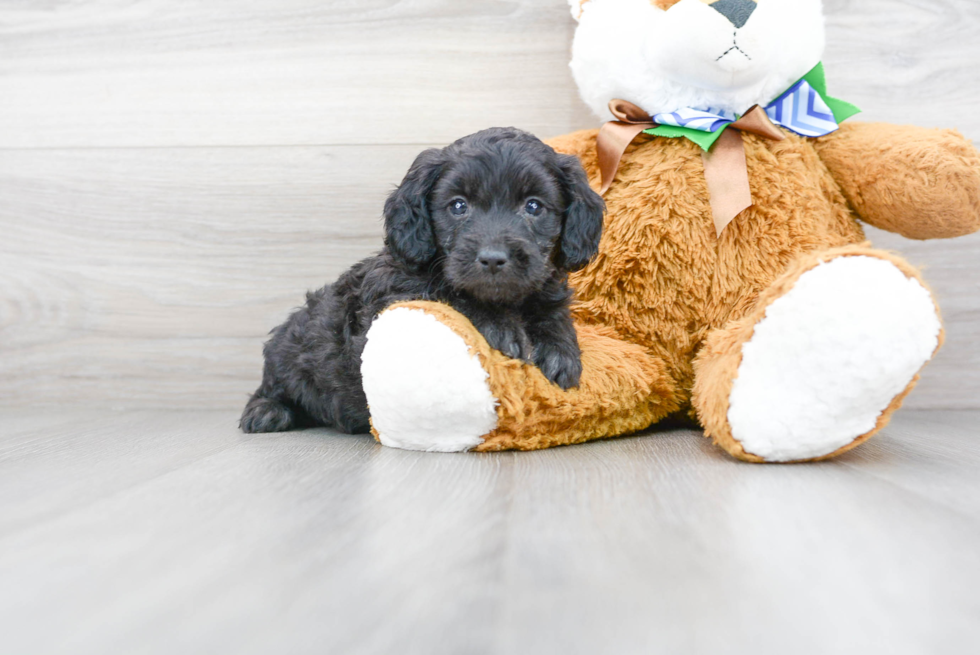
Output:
0,409,980,655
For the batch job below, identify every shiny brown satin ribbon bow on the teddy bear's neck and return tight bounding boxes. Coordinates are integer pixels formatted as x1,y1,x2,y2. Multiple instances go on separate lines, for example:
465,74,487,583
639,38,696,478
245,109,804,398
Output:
596,100,786,237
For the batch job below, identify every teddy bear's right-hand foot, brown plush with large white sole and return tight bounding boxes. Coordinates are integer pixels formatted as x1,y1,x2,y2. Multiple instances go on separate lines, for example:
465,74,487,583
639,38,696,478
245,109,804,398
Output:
693,246,943,462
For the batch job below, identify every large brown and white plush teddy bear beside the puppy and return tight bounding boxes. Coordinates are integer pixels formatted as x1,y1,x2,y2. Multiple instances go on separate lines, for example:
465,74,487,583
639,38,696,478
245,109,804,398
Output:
362,0,980,462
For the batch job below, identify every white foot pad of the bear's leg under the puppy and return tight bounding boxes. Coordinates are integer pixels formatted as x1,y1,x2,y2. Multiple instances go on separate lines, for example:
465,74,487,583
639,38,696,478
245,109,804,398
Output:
361,307,497,452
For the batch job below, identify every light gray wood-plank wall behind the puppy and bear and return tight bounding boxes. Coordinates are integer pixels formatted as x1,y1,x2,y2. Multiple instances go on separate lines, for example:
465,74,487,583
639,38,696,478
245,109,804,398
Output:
0,0,980,408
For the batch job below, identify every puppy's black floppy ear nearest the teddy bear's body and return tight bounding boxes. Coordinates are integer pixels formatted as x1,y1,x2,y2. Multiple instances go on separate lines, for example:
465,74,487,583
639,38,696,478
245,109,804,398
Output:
557,155,606,271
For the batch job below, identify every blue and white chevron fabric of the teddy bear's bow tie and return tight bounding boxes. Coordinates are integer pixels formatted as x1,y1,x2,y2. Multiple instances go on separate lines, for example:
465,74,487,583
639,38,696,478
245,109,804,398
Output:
653,80,840,137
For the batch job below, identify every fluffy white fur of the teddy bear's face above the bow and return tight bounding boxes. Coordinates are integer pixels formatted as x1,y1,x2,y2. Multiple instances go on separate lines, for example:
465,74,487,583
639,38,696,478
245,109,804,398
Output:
570,0,824,120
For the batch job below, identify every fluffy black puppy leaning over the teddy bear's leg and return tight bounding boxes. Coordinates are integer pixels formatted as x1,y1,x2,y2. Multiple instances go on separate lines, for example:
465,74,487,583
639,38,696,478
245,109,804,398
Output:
241,128,604,433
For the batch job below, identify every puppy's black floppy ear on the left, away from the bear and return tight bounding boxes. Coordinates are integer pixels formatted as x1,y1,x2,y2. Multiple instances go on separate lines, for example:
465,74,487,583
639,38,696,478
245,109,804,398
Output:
385,148,443,267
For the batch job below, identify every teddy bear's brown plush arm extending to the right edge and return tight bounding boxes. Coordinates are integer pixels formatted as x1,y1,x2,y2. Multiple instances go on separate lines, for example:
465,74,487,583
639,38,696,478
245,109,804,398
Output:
815,123,980,239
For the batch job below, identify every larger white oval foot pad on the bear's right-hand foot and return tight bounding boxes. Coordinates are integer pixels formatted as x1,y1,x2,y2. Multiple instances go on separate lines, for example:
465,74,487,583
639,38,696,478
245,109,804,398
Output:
728,256,942,462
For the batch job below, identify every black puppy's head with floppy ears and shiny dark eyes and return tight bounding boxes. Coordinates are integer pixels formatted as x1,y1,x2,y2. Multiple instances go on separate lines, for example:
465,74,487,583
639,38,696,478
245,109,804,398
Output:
385,128,604,303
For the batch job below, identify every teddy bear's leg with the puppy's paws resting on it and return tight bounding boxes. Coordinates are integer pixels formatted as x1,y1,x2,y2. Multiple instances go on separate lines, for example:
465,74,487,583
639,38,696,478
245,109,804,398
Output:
361,301,678,452
